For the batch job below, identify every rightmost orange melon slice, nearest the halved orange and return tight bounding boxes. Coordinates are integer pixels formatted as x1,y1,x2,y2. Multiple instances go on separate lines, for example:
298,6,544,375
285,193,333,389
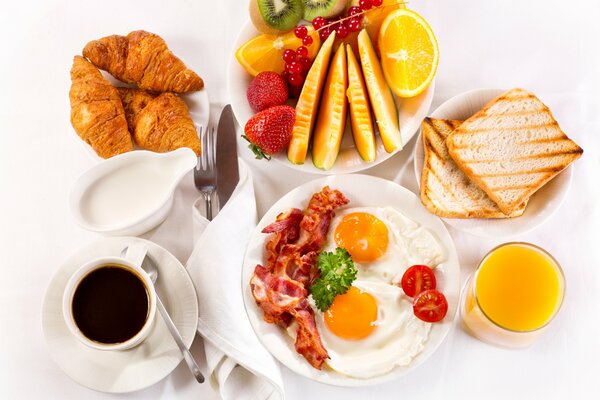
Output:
354,29,402,153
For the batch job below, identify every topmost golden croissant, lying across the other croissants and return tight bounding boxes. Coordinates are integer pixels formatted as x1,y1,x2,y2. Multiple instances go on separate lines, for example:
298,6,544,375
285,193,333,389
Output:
83,31,204,93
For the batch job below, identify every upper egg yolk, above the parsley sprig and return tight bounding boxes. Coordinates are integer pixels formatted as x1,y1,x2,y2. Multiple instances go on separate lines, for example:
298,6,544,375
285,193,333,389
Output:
334,212,389,263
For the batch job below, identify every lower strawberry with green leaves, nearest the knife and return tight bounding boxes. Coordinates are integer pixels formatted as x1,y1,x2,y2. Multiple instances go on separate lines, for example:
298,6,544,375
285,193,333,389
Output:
242,106,296,160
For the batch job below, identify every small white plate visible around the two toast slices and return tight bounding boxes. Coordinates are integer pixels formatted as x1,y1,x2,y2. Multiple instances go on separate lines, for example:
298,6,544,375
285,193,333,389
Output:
414,89,573,237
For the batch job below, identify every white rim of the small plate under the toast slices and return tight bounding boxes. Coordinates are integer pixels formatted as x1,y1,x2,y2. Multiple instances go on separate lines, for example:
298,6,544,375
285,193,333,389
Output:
413,88,574,239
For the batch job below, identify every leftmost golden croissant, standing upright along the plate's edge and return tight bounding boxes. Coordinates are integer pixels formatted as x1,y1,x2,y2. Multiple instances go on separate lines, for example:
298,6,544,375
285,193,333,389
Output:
69,56,133,158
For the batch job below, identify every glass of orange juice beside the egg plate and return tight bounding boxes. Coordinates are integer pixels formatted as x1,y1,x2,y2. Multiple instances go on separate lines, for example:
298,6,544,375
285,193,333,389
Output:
461,242,565,348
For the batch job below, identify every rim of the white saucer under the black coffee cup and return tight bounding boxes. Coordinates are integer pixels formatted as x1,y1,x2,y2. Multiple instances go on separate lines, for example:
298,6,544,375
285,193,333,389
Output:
41,236,198,394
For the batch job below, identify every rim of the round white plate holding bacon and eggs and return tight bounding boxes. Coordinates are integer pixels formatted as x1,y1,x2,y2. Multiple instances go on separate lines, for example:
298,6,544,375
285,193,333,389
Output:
240,174,461,387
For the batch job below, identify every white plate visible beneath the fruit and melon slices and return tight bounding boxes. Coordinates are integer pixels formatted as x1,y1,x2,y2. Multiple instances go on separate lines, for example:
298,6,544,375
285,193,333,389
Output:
227,21,435,175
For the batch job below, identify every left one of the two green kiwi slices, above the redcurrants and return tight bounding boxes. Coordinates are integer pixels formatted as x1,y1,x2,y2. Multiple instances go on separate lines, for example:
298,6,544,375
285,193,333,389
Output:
251,0,304,32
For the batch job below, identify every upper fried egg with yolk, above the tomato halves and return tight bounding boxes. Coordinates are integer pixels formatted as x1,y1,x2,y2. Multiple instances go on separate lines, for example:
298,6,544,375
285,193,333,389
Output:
323,207,444,284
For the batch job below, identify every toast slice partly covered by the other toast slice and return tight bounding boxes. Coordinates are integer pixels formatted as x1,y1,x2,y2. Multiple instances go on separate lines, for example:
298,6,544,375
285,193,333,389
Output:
421,118,527,218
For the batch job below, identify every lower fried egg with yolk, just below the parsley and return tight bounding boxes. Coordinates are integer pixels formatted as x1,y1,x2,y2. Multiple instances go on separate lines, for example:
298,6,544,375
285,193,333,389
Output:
309,280,431,378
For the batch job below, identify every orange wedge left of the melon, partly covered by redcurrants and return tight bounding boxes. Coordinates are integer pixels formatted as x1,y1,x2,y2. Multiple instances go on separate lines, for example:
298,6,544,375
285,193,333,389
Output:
235,26,321,76
